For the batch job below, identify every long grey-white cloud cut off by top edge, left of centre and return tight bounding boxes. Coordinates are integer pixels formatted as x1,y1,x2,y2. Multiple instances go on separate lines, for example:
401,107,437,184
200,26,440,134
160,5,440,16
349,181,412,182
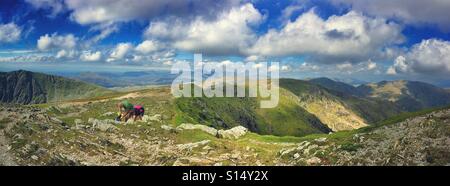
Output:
65,0,240,24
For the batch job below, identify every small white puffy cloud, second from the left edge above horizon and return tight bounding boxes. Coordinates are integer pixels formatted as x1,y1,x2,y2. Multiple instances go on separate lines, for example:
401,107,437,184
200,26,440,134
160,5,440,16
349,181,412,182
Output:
37,33,78,50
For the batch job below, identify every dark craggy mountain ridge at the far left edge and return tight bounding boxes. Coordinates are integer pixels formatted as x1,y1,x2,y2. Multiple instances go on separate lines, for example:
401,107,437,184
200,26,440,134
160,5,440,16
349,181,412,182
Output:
0,70,113,104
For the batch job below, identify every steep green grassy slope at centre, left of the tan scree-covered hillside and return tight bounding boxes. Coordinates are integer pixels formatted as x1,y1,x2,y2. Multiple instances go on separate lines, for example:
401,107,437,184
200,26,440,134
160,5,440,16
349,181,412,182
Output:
174,83,330,136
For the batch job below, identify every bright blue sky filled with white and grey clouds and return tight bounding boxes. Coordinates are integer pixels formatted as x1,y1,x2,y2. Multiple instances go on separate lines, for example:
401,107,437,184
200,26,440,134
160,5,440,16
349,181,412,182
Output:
0,0,450,87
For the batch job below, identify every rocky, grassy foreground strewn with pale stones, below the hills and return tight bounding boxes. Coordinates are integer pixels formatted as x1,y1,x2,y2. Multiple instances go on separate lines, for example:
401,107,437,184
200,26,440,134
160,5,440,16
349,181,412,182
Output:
0,96,450,166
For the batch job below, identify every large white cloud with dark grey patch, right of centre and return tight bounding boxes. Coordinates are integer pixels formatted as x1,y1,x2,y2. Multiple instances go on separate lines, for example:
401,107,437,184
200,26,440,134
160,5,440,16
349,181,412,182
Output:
249,10,403,62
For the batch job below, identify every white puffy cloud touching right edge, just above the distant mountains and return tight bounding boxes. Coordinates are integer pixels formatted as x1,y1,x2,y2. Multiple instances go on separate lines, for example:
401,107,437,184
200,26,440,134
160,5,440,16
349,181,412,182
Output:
386,39,450,75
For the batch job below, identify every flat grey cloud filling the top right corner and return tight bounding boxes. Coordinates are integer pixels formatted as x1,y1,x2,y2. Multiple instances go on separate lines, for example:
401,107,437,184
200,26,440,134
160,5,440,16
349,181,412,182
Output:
331,0,450,31
